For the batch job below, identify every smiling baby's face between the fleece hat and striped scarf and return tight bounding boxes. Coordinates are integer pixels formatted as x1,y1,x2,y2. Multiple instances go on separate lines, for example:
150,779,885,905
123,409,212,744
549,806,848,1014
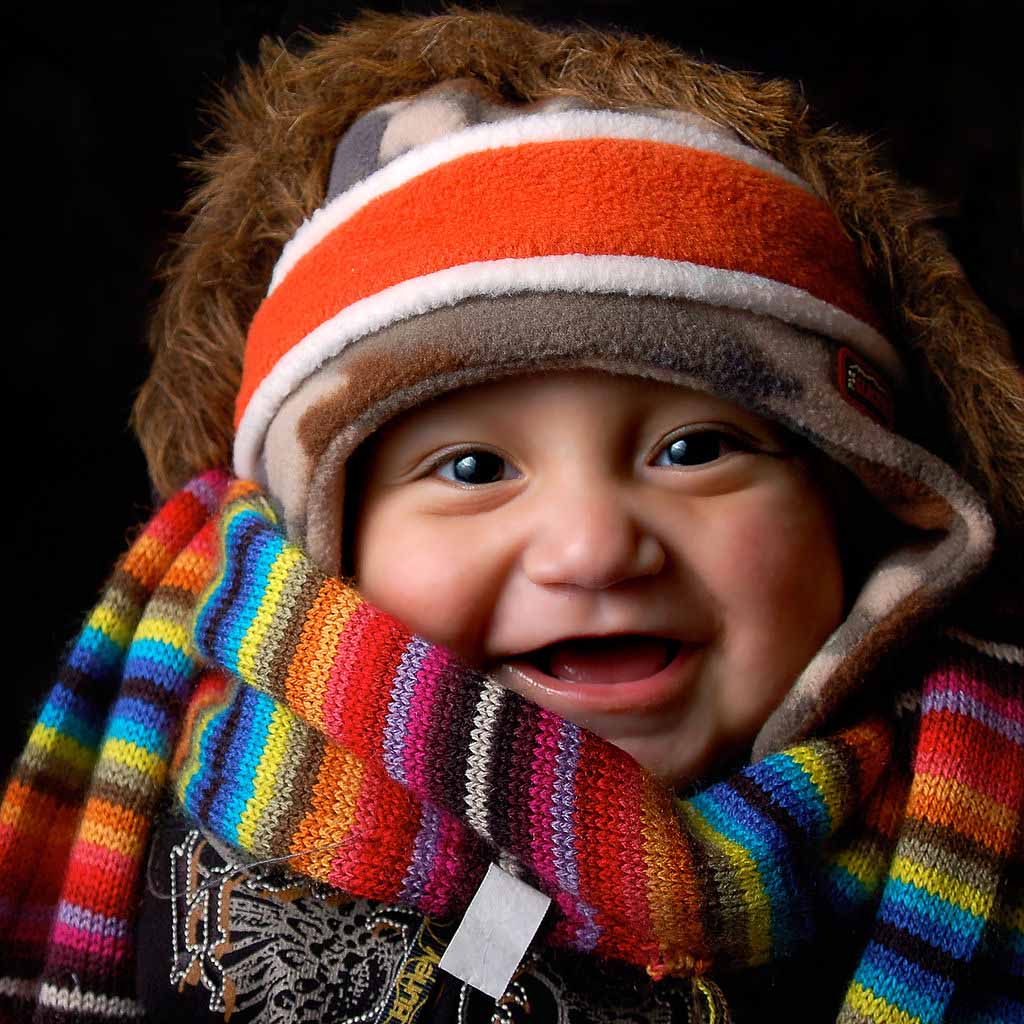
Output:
348,371,843,785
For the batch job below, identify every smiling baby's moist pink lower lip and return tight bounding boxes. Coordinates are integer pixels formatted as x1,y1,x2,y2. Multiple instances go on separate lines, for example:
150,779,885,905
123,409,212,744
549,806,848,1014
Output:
490,643,700,717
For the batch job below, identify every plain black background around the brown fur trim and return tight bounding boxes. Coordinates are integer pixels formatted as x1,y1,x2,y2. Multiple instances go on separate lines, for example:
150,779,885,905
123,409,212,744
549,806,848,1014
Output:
0,0,1024,775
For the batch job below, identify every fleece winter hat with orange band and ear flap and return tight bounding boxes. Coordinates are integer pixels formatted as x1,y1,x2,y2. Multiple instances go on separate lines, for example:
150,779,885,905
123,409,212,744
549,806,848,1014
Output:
234,80,992,753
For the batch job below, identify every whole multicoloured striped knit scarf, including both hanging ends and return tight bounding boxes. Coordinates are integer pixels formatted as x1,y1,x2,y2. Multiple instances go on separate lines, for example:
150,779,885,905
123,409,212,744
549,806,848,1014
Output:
0,472,1024,1024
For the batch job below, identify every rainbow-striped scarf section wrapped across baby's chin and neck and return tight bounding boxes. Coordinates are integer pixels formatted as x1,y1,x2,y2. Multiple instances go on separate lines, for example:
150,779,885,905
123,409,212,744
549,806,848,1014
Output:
178,485,889,974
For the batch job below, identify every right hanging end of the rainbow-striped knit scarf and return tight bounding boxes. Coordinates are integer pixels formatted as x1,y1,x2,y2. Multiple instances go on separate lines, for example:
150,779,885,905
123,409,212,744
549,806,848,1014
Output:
840,655,1024,1024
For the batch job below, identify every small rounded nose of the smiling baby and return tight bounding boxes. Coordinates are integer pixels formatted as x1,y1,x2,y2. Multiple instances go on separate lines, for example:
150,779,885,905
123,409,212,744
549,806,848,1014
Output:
523,489,666,590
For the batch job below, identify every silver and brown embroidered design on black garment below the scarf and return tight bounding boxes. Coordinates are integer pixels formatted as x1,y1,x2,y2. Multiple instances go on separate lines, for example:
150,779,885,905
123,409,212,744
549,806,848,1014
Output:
168,828,688,1024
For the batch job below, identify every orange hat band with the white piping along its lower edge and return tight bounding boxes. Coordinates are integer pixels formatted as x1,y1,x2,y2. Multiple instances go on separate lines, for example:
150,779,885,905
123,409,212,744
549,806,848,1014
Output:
236,137,886,471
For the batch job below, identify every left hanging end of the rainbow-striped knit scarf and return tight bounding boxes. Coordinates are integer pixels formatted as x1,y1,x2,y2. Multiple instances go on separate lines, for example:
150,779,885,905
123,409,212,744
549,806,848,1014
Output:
0,473,228,1022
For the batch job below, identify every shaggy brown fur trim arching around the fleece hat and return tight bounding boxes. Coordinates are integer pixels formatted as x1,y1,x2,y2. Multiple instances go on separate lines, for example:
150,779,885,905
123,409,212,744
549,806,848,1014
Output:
132,6,1024,536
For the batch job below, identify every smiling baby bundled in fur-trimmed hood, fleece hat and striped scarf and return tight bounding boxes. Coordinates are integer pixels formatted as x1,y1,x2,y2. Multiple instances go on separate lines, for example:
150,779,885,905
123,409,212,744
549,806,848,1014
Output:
0,11,1024,1024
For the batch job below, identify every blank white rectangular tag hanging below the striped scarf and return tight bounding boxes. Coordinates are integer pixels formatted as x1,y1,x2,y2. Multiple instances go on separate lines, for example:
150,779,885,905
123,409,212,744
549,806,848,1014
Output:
439,864,551,999
